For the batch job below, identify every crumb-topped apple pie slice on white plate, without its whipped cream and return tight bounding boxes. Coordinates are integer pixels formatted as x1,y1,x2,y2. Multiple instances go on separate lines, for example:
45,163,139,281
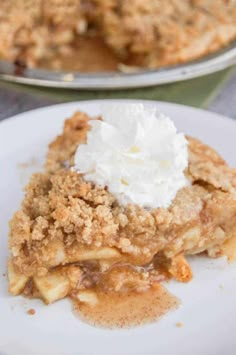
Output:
8,105,236,328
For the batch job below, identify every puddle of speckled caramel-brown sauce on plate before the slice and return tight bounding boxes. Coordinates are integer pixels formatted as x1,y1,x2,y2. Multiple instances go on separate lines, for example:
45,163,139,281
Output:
75,284,179,328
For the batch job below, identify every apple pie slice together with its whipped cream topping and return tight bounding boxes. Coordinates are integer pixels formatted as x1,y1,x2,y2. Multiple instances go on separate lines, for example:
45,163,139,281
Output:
8,105,236,318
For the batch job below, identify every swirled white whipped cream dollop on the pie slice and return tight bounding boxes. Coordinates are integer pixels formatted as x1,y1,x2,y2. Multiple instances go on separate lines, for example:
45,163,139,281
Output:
74,103,188,208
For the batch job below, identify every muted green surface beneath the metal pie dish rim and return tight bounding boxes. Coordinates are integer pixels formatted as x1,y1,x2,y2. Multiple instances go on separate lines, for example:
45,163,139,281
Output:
0,68,235,107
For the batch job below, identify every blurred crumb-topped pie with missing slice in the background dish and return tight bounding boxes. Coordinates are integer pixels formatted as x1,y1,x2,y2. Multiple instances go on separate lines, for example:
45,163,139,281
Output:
0,0,236,71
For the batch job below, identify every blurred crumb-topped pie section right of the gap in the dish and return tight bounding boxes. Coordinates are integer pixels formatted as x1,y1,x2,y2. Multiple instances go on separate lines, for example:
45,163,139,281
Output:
93,0,236,68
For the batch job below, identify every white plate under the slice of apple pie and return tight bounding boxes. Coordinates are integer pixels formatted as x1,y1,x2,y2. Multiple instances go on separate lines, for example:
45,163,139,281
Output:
0,101,236,355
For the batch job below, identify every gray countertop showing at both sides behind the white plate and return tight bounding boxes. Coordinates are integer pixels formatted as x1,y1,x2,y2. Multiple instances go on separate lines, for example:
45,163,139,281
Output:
0,72,236,120
